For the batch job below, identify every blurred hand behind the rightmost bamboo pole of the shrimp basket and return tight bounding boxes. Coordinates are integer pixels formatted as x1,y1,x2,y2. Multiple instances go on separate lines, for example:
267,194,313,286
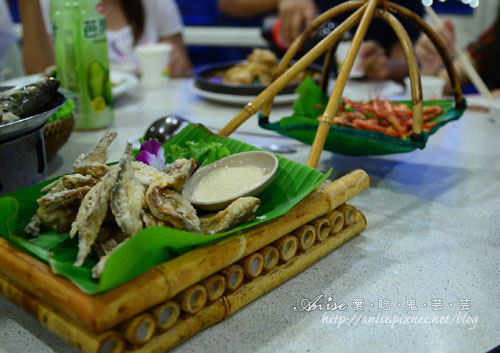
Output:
415,19,455,75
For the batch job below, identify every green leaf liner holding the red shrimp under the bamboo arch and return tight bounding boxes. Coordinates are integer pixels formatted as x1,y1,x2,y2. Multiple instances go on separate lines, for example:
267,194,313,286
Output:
259,78,466,156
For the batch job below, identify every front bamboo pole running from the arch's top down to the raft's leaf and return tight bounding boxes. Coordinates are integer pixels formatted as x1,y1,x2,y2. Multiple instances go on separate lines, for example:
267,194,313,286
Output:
306,0,378,168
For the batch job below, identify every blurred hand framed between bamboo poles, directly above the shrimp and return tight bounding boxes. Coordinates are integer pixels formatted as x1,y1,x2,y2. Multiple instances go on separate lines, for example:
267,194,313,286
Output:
358,40,390,80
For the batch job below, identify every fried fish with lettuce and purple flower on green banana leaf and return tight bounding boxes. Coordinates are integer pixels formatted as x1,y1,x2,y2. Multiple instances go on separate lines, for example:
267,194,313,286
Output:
0,124,329,294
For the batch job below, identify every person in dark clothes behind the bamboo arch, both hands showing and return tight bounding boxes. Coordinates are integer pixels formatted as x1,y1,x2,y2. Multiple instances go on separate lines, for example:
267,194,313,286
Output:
218,0,423,81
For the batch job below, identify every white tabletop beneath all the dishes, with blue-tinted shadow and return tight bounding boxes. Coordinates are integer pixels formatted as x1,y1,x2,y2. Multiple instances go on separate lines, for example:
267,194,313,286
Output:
0,80,500,353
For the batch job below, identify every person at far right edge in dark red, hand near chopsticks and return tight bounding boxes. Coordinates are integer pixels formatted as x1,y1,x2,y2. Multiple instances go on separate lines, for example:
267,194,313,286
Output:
415,9,500,96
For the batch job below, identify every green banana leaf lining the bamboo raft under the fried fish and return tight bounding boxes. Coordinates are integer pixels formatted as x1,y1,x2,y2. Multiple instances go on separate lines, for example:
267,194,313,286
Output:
0,124,331,294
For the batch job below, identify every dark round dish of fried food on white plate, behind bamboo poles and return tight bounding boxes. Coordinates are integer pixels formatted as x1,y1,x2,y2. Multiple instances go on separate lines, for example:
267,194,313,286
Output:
192,49,321,104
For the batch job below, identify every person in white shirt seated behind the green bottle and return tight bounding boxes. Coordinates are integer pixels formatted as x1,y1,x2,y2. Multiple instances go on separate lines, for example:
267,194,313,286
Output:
19,0,192,77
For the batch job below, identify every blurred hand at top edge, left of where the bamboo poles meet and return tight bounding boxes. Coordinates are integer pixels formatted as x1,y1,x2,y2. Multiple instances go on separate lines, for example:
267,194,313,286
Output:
278,0,318,43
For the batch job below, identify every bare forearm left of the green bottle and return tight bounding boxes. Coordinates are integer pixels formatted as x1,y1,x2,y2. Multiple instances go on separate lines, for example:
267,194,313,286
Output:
19,0,55,74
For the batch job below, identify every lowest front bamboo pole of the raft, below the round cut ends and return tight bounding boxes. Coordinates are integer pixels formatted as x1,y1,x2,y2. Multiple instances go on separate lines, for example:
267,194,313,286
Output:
130,212,366,353
